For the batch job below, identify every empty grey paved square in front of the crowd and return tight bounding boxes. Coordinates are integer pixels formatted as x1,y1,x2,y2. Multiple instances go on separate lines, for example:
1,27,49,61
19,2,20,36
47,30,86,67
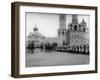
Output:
26,50,89,67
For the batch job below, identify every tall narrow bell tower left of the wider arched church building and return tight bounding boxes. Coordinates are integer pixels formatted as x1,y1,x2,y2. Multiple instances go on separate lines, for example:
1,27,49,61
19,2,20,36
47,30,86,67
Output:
58,14,68,46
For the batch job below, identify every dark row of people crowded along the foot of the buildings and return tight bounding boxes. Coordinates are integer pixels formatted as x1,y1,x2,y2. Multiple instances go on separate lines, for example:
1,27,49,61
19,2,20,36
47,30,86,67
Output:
26,42,89,54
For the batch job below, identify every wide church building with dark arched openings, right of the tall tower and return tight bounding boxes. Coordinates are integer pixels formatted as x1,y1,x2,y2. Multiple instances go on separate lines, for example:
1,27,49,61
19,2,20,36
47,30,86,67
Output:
68,15,89,46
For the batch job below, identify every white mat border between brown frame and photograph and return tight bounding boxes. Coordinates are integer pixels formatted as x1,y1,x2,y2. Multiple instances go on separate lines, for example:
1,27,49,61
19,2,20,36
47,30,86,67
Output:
19,6,95,74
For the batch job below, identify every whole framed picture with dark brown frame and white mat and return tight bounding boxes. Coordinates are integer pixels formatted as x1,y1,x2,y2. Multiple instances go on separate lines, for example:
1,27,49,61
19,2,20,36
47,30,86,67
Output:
11,2,97,77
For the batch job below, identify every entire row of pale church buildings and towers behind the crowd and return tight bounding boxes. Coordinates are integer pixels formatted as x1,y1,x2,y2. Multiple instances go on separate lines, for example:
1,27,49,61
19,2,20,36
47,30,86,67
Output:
26,14,89,47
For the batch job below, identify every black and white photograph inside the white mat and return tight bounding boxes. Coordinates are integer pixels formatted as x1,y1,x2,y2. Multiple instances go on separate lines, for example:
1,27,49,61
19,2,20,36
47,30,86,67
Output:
25,12,91,67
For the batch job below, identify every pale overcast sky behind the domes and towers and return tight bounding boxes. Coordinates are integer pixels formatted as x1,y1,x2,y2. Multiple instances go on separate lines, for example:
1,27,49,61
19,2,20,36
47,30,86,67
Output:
26,13,90,37
